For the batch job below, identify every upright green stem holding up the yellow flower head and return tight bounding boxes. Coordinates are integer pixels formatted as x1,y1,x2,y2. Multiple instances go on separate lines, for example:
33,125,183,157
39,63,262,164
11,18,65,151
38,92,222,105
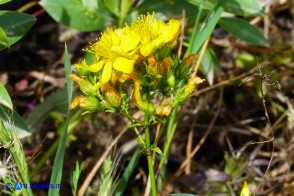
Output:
145,113,157,196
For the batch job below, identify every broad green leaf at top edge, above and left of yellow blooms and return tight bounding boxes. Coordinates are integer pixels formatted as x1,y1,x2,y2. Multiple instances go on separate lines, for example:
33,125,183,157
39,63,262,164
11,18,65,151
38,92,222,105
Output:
40,0,113,31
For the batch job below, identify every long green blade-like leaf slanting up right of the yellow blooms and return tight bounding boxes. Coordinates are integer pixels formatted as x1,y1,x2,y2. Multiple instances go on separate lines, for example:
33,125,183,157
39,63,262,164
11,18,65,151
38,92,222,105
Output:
190,1,224,54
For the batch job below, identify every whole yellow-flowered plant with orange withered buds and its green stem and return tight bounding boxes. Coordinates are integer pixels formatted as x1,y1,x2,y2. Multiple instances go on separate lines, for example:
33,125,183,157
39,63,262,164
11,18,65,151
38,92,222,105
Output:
70,14,203,195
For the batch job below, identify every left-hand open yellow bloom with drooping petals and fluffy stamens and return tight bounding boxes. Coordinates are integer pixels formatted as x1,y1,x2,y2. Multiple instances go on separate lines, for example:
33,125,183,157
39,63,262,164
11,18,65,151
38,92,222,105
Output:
89,27,139,84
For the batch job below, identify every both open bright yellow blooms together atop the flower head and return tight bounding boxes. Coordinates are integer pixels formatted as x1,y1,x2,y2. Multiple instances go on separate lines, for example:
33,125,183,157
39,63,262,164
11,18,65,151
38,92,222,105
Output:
72,14,180,86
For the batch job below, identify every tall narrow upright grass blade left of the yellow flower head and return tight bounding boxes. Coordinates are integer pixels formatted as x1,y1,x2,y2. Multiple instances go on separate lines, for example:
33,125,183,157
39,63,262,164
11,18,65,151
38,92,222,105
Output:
48,45,73,196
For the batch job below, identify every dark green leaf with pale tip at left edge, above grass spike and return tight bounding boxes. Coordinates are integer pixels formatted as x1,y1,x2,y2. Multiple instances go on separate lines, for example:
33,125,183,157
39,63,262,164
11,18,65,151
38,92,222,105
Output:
0,105,31,139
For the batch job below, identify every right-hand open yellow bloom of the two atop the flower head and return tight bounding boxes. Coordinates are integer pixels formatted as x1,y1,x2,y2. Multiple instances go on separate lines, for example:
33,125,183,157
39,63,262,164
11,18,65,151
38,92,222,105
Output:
131,14,180,57
